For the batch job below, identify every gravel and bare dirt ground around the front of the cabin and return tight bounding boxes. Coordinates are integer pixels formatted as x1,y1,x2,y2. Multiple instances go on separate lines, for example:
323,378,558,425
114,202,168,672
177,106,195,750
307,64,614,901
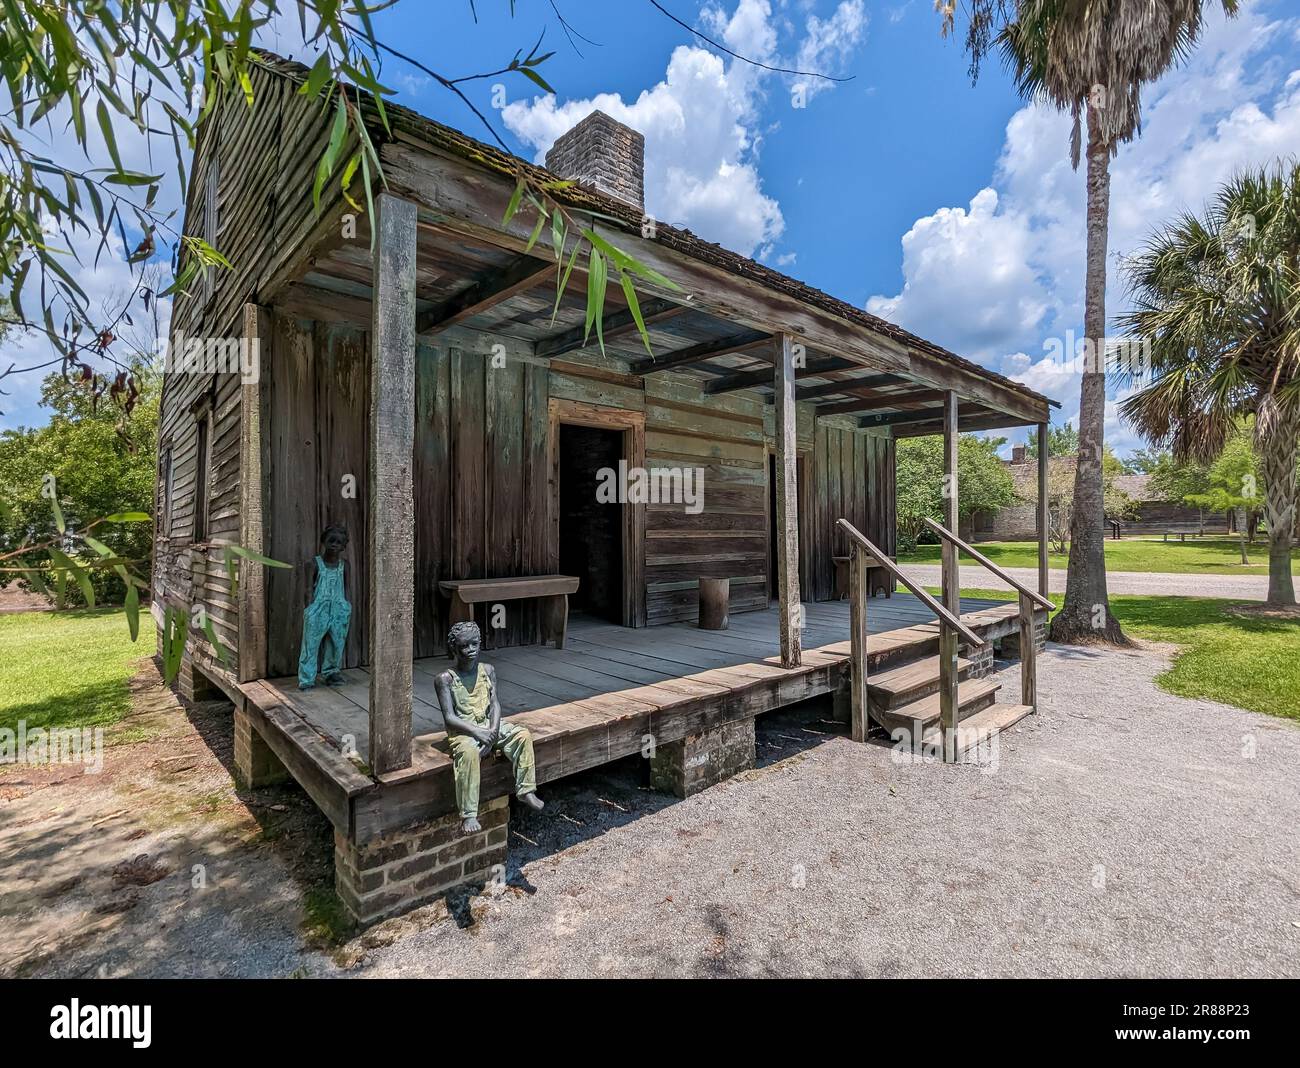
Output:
0,647,1300,977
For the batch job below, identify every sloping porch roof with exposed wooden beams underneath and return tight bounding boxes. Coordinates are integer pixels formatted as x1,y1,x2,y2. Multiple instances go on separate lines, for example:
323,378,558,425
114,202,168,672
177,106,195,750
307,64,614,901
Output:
260,52,1057,437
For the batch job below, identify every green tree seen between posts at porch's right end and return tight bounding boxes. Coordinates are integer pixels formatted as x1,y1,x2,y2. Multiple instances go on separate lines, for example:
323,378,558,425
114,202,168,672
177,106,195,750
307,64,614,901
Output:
896,434,1015,550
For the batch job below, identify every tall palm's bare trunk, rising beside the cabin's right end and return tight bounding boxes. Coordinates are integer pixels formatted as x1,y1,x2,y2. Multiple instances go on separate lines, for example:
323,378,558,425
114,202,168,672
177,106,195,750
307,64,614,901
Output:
1052,107,1127,644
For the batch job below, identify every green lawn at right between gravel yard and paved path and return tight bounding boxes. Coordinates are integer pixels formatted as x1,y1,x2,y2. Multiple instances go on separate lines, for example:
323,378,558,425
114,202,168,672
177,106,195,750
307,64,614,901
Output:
932,589,1300,720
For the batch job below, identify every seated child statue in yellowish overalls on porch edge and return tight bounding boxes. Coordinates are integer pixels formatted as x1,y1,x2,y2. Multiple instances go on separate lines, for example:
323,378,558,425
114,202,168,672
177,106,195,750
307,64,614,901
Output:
433,622,542,834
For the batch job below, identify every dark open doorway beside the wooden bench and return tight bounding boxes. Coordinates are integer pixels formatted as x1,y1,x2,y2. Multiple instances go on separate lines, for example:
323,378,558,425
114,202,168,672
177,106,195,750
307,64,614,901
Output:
559,424,625,624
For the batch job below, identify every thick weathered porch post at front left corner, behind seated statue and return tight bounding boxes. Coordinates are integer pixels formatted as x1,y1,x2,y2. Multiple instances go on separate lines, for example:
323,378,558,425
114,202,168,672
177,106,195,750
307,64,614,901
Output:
365,194,416,776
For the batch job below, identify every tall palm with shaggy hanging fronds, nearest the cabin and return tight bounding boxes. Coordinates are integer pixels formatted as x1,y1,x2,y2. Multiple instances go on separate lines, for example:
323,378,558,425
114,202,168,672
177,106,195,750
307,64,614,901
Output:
940,0,1238,644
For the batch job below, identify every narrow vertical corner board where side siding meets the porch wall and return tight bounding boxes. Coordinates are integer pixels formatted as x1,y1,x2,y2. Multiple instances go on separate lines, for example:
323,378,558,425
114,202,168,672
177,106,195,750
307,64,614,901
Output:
237,304,272,682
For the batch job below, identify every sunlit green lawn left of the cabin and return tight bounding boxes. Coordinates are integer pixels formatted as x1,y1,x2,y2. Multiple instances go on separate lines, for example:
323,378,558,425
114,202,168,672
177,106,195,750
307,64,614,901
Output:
0,608,157,730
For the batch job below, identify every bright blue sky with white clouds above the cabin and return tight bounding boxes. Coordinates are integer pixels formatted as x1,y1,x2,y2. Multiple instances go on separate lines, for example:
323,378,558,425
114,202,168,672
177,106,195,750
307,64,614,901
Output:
0,0,1300,453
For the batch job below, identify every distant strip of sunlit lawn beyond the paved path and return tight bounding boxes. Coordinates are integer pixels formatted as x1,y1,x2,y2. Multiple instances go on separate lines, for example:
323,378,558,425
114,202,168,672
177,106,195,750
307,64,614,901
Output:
898,538,1300,576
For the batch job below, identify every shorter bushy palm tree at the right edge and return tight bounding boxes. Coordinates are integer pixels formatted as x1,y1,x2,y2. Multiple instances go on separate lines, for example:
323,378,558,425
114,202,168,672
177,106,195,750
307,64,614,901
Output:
1121,160,1300,604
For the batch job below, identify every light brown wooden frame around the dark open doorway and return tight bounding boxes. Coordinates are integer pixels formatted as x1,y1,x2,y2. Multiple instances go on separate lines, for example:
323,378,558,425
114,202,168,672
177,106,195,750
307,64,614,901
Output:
546,396,646,626
